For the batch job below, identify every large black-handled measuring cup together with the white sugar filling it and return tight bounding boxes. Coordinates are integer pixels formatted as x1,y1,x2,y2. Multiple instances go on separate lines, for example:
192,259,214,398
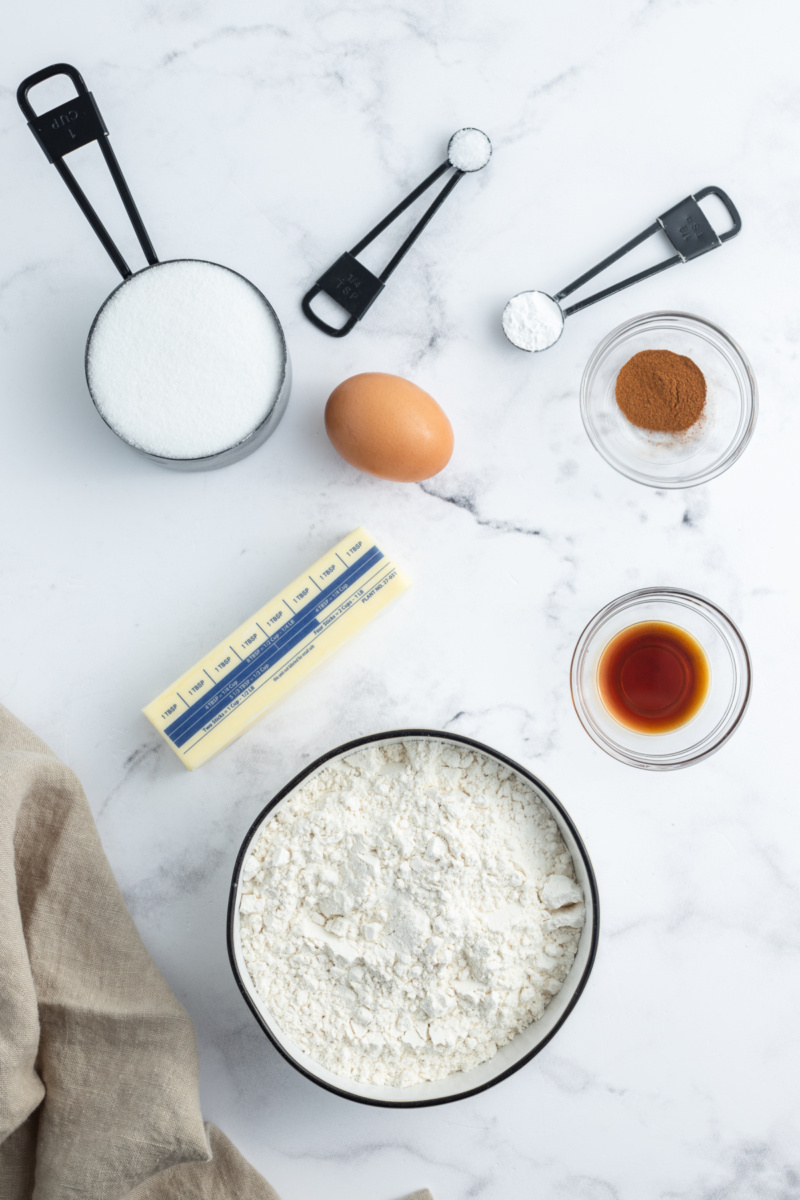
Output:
17,64,290,470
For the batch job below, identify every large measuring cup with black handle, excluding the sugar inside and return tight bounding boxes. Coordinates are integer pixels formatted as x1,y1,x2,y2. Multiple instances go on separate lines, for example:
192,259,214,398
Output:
17,62,291,470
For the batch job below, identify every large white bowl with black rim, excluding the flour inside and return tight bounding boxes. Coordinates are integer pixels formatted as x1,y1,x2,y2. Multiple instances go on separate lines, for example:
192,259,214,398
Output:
228,730,600,1109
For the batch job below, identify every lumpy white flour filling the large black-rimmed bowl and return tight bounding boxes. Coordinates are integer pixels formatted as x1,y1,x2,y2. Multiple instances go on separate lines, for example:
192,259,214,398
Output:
240,740,584,1086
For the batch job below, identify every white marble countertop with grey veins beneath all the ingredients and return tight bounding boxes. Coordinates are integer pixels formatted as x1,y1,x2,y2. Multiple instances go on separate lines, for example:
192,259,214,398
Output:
0,0,800,1200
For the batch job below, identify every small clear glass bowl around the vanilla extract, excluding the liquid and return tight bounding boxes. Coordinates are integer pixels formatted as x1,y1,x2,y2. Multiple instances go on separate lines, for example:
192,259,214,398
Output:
570,588,751,770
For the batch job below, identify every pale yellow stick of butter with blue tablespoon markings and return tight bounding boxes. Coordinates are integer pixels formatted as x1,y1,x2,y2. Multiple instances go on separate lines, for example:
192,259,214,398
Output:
143,529,409,770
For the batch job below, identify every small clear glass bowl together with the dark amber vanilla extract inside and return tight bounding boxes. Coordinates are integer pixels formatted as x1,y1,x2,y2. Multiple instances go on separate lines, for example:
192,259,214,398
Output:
570,588,752,770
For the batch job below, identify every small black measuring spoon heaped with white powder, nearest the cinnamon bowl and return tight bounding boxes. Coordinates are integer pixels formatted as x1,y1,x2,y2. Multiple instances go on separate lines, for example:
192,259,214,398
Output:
503,187,741,352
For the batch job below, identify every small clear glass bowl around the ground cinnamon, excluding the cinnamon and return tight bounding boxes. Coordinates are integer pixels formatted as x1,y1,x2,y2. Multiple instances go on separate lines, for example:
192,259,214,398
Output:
581,312,758,487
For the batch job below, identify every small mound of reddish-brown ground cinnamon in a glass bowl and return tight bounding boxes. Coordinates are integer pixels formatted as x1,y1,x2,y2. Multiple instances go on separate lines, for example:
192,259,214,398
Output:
614,350,706,433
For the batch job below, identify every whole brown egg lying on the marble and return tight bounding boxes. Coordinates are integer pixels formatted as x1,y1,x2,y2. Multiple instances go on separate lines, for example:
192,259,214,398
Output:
325,371,453,484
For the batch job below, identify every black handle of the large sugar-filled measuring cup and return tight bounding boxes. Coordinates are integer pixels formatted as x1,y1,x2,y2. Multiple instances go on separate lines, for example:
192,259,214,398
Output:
17,62,158,280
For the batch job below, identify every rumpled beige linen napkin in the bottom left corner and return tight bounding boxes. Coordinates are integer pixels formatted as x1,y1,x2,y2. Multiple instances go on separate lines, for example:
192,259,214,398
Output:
0,706,429,1200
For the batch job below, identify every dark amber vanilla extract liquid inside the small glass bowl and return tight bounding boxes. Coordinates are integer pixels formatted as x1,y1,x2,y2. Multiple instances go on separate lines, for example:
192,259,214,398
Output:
597,620,711,733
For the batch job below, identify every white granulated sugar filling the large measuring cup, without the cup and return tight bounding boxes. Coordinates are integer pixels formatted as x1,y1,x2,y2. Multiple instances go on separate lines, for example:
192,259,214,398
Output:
86,259,287,458
